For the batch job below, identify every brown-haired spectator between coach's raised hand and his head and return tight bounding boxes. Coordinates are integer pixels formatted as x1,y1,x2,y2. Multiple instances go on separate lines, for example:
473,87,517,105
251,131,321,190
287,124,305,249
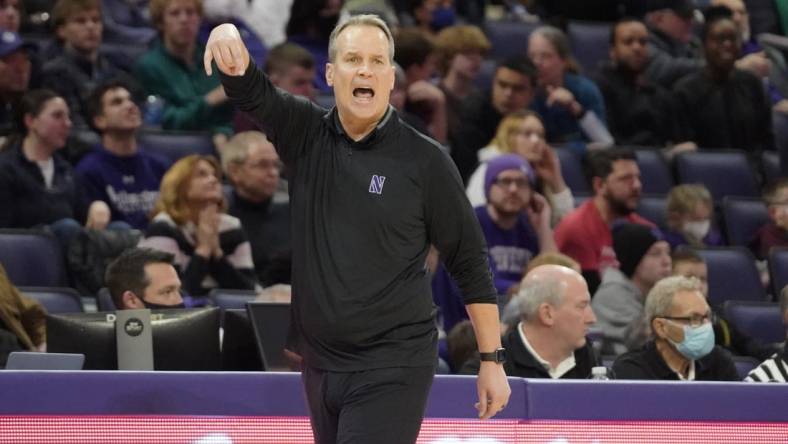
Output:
233,42,316,133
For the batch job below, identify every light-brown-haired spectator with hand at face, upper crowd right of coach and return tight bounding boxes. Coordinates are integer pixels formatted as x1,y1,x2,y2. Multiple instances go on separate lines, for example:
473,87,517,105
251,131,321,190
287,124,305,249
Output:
435,25,492,132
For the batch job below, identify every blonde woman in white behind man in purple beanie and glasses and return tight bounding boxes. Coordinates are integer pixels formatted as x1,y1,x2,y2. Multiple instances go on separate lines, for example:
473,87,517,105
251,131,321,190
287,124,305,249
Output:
467,111,574,226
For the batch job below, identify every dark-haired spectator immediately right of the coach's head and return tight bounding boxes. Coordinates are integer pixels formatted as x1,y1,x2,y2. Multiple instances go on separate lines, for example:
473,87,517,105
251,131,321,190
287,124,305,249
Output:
394,28,448,144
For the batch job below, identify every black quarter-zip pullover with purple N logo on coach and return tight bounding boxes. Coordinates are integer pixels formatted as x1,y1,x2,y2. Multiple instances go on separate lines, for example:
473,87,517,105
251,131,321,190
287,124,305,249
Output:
222,64,496,372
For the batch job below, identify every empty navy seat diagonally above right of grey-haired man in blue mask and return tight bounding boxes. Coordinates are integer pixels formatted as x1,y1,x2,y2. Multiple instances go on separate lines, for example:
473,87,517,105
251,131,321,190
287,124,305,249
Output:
697,247,766,307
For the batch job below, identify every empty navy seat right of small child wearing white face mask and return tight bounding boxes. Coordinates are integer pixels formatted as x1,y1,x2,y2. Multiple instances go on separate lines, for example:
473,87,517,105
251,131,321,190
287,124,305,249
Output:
722,196,769,246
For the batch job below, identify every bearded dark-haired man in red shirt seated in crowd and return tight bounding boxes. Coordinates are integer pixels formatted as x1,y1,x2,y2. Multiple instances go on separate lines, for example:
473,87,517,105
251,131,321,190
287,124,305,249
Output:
555,149,651,293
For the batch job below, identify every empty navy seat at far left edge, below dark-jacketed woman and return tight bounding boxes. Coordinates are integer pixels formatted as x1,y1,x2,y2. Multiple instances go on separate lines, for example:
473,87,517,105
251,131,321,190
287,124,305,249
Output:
0,229,68,287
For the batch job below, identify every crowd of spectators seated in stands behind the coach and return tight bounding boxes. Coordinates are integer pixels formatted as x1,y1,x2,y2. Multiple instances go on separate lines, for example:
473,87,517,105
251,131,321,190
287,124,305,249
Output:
0,0,788,380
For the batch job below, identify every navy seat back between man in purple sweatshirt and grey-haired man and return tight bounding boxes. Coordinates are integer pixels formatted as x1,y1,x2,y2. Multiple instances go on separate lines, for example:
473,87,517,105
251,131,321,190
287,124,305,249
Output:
138,130,216,168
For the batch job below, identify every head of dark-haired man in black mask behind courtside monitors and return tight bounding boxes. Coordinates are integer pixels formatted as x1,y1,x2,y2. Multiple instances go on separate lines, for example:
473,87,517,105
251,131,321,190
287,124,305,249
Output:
105,248,184,310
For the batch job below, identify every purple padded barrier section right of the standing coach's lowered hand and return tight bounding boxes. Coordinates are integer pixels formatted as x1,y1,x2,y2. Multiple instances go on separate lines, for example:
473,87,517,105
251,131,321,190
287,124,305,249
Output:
524,379,788,422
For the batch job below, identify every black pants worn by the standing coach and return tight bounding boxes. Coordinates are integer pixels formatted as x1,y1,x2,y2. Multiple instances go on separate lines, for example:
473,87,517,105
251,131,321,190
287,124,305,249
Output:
301,367,435,444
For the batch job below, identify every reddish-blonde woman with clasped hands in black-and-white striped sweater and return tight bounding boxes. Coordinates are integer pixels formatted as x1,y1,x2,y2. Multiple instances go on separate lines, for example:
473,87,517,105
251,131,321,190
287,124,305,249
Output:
139,154,256,296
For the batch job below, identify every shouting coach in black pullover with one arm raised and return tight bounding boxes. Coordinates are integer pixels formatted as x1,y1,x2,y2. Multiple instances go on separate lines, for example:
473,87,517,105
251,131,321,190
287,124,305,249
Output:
205,15,510,443
